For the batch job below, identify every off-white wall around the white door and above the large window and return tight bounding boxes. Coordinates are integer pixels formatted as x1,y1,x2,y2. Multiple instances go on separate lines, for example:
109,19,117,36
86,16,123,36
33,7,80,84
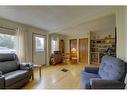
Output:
0,18,49,65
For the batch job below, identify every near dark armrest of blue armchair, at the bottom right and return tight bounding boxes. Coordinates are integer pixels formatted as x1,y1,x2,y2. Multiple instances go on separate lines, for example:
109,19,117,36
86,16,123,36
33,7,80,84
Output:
91,80,125,89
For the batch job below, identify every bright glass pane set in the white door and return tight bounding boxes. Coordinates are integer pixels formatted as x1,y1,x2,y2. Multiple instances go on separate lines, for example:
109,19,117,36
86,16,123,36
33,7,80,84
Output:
36,37,45,52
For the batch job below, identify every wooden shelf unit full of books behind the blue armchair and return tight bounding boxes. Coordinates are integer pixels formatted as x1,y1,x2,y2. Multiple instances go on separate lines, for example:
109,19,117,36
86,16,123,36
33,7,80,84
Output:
90,38,116,64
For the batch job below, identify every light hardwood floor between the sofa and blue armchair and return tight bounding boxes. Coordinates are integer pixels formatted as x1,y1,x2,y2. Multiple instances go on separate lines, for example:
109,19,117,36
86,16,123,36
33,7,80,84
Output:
23,63,84,89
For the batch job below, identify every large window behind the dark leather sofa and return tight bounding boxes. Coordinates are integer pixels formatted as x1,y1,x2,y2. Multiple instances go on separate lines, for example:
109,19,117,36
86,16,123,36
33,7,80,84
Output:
0,33,16,53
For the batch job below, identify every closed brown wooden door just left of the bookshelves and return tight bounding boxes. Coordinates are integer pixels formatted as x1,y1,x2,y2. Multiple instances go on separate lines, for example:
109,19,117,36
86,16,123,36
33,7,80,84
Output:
79,38,88,64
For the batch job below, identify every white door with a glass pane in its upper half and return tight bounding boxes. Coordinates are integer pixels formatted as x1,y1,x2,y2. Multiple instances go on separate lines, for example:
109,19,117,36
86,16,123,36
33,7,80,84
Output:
33,34,46,65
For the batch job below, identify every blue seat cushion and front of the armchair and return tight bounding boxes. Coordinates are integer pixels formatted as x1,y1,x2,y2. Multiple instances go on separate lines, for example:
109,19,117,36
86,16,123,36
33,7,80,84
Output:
80,71,100,89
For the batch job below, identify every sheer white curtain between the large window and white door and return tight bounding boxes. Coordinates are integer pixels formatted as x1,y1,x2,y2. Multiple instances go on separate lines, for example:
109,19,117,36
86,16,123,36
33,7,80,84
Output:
16,27,29,62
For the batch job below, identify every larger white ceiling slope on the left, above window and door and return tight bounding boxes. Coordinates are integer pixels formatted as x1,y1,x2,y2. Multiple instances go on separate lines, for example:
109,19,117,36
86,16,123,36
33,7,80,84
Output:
0,6,116,32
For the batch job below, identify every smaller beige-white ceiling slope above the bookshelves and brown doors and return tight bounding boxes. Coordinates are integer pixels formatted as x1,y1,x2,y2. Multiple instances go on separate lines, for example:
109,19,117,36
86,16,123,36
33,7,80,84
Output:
58,15,116,37
